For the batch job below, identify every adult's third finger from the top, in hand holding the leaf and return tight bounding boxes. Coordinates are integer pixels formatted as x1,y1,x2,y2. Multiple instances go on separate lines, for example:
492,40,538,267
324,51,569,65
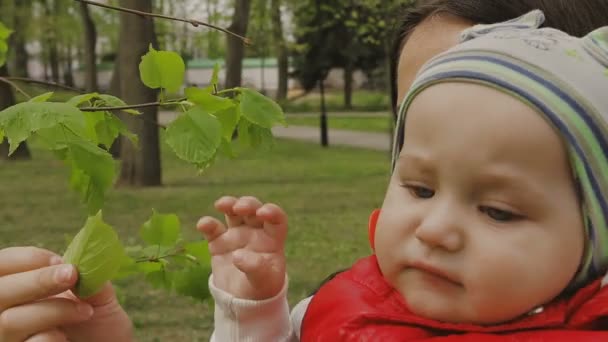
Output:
0,298,93,341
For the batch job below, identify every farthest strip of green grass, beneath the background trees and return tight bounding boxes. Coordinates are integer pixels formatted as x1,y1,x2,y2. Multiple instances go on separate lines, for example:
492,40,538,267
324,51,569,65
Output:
281,90,390,113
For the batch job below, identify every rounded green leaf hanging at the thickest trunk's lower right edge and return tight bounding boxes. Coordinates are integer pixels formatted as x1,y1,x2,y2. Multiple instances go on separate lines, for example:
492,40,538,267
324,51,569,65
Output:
165,106,222,168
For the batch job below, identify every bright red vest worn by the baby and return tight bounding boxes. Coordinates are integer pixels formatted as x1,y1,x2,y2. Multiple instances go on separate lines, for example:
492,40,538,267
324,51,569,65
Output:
301,256,608,342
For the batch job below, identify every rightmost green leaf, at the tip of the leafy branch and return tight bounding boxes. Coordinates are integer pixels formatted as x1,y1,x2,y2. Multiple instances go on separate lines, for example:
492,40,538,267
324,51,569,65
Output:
239,88,286,128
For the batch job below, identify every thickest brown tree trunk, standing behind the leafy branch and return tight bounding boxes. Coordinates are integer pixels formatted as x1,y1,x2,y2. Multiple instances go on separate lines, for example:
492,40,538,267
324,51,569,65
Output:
116,0,161,186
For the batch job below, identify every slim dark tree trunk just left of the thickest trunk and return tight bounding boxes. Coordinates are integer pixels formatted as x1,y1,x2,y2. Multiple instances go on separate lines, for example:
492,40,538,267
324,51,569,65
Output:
80,2,98,92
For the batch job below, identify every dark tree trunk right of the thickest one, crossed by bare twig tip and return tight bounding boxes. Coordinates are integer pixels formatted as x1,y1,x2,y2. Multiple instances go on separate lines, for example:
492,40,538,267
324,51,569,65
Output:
226,0,251,88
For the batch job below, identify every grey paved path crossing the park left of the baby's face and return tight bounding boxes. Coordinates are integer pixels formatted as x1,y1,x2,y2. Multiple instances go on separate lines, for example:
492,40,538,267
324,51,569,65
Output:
159,112,391,151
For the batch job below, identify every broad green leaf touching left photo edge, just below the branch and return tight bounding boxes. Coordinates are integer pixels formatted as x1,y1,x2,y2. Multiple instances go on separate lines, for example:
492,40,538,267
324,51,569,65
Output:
0,102,85,154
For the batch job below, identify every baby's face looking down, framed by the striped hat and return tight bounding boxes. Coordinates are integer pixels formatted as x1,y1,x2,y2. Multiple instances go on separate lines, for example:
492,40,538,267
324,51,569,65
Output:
376,83,584,324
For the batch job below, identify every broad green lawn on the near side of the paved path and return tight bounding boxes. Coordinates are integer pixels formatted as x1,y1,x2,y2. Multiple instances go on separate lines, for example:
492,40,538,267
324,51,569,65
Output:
0,140,389,341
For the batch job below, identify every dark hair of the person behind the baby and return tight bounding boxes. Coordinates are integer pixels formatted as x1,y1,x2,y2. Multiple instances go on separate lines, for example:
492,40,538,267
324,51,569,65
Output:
390,0,608,115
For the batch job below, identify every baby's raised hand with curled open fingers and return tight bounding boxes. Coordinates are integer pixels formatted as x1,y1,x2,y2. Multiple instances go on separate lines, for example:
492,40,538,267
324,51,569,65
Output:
197,196,287,300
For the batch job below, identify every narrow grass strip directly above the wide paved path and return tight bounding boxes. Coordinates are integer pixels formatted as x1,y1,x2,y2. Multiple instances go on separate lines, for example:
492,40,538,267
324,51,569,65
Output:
287,113,392,133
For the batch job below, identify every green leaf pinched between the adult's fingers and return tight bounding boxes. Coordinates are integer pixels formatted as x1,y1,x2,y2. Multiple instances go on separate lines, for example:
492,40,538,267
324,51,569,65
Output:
63,211,126,297
